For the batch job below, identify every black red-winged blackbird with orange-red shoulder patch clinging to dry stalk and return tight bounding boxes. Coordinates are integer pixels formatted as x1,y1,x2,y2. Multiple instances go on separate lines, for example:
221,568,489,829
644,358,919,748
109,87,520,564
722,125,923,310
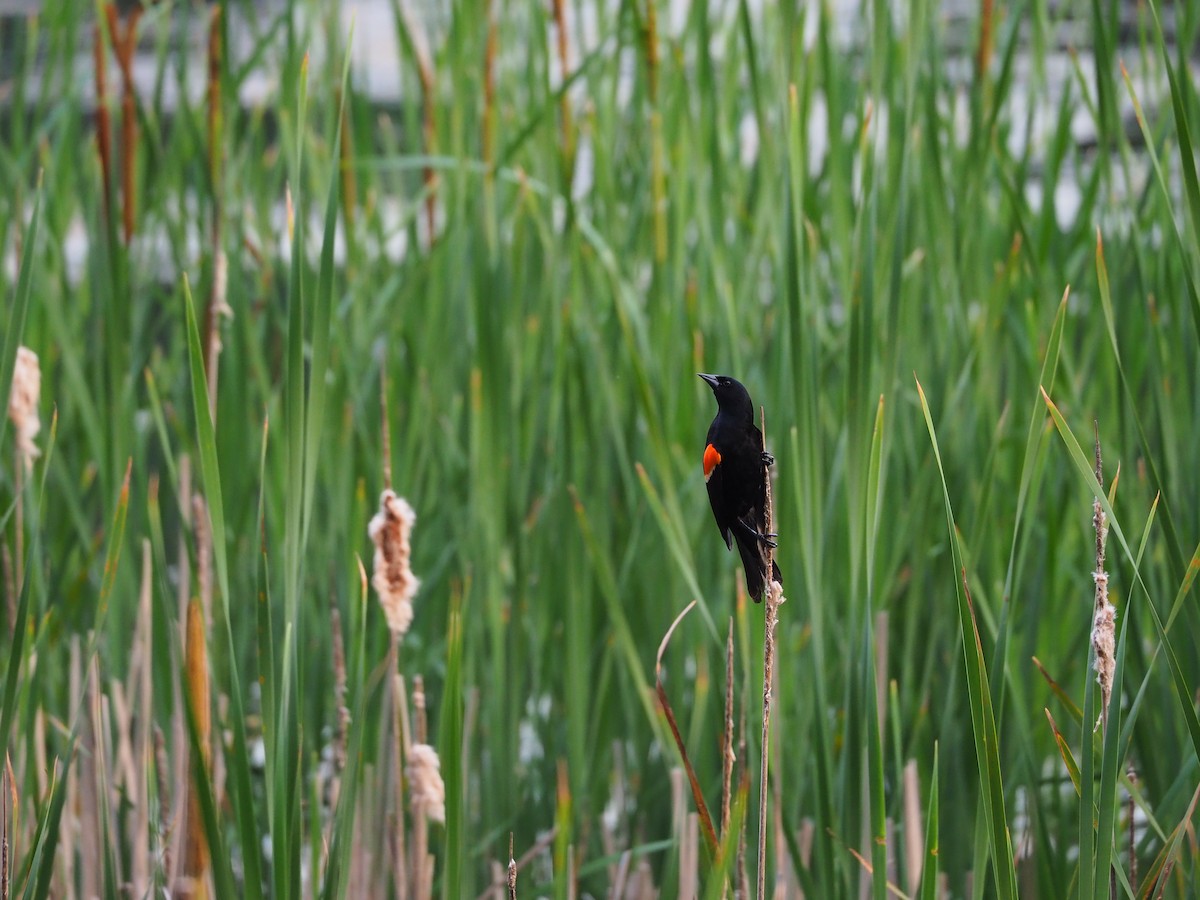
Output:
700,374,784,604
